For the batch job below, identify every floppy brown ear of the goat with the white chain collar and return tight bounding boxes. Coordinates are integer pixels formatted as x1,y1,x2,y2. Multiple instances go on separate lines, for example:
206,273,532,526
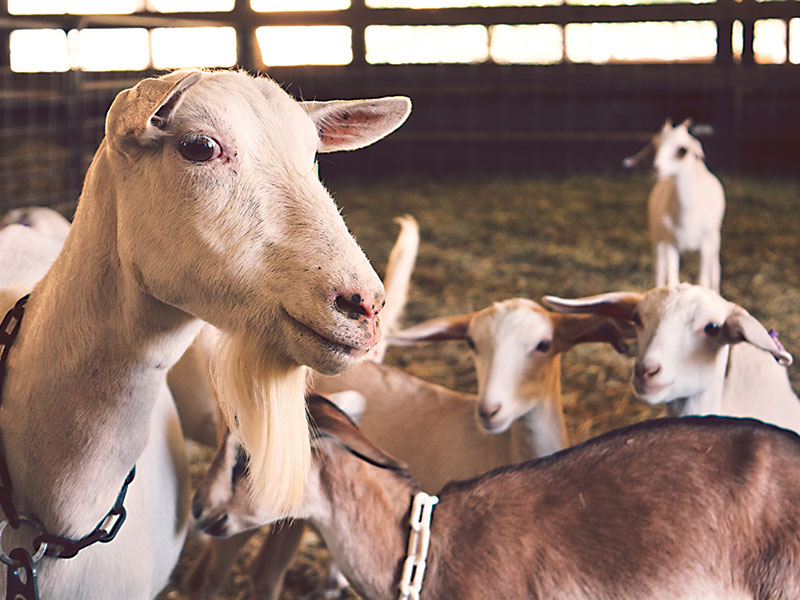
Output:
307,394,406,470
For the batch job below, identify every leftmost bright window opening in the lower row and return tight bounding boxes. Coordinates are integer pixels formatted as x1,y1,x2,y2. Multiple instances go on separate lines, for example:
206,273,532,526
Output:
9,29,69,73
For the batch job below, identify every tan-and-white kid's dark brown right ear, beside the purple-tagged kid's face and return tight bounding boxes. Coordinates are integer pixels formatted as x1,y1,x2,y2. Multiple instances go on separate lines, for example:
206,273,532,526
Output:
551,314,636,354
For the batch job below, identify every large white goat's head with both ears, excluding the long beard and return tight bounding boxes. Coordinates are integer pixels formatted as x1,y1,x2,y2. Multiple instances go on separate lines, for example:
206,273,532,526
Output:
106,71,410,373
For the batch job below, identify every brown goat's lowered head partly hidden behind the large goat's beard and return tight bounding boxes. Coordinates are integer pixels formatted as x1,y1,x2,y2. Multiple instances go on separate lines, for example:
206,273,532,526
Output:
192,392,406,537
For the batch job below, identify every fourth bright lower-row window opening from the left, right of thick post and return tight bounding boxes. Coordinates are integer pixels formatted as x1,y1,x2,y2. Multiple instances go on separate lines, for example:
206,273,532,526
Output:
256,25,353,67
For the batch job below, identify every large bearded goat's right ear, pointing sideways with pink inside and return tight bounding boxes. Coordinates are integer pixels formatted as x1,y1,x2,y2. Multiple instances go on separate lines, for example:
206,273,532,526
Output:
301,96,411,152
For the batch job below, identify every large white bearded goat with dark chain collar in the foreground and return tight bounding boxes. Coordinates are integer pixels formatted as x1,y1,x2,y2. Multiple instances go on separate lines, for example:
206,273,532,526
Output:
0,71,410,600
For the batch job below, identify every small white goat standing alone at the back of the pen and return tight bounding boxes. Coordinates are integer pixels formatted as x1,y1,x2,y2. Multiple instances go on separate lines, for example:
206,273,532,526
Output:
624,119,725,291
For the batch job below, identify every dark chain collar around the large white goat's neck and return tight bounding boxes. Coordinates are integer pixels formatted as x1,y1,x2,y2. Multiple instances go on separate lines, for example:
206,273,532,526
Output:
0,295,136,584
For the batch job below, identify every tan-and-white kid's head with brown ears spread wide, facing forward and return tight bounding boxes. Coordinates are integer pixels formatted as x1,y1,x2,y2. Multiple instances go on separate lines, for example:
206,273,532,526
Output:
389,298,625,433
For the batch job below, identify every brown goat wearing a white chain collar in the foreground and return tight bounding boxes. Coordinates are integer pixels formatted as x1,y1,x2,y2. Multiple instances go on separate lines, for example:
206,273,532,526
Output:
195,397,800,600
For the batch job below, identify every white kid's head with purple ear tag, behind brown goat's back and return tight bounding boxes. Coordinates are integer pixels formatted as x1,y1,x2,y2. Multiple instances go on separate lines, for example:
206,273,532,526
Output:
545,283,792,404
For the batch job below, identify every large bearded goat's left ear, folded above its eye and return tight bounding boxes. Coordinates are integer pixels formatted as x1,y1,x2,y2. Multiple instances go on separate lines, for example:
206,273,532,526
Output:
106,71,203,149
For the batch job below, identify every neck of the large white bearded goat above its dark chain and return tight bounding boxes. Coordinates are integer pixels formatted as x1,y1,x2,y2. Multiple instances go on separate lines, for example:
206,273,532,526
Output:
0,142,199,537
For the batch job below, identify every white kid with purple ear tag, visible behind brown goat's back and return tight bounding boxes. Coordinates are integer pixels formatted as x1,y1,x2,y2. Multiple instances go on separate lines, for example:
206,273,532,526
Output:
544,283,800,432
